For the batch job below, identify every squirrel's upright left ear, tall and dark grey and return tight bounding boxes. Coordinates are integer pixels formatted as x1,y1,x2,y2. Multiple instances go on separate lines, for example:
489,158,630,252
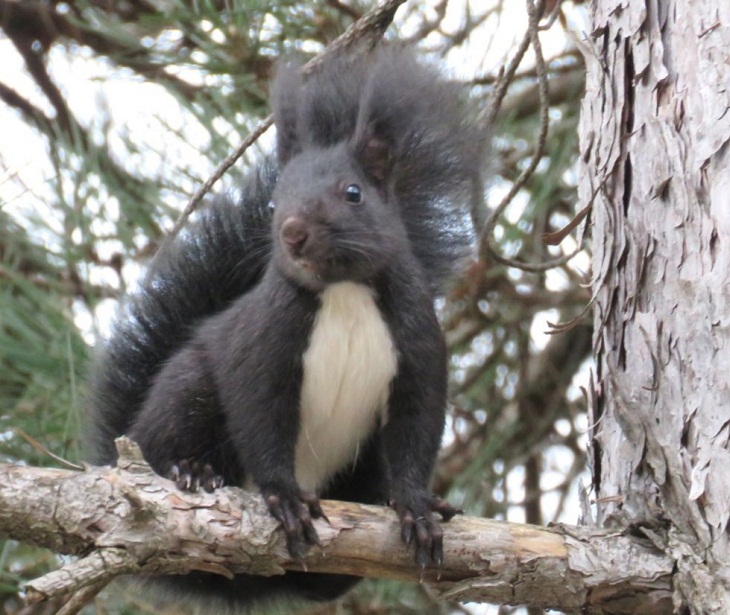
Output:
270,63,303,167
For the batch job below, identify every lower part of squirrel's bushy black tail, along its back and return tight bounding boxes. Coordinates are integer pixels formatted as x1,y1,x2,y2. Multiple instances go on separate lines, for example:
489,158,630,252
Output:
87,160,276,464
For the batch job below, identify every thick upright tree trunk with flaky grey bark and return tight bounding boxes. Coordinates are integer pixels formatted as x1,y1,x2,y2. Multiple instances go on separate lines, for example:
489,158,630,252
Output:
580,0,730,613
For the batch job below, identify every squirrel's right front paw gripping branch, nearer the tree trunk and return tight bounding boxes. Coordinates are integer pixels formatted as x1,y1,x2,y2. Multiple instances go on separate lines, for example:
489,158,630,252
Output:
390,494,463,568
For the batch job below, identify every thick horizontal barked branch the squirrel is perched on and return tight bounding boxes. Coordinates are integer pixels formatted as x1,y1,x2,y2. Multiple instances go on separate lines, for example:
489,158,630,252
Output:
0,438,673,614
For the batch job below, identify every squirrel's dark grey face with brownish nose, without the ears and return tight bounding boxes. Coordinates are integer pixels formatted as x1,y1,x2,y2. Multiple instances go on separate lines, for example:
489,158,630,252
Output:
272,144,407,291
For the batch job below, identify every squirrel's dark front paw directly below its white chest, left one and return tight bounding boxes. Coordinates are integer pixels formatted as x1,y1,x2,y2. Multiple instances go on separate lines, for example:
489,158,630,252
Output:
261,486,329,560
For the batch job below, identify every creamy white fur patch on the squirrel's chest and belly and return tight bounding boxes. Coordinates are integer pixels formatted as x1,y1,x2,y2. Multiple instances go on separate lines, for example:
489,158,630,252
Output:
295,282,397,491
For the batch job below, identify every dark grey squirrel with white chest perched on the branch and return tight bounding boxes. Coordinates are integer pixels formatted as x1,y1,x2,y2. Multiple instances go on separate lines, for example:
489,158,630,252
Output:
89,48,485,612
